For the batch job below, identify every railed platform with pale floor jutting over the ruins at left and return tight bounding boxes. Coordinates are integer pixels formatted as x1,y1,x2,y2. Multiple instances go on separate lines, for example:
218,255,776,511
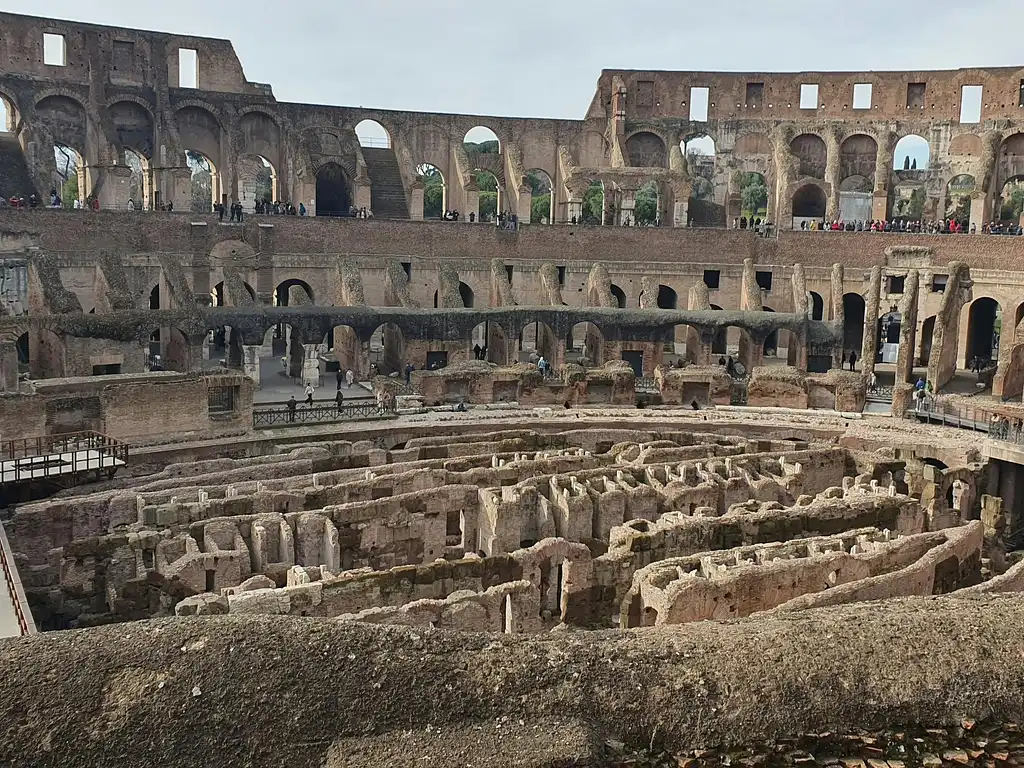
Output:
0,432,128,483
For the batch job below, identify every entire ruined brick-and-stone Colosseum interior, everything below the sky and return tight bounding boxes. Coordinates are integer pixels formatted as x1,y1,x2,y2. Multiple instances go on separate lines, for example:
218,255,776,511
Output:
0,7,1024,768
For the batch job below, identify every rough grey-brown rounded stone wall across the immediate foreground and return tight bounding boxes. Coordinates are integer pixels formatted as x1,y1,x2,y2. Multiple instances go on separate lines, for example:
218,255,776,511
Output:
0,596,1024,768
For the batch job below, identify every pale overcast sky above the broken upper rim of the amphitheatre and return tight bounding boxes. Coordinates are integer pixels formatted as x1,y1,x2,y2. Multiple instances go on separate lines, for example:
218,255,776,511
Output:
14,0,1024,119
